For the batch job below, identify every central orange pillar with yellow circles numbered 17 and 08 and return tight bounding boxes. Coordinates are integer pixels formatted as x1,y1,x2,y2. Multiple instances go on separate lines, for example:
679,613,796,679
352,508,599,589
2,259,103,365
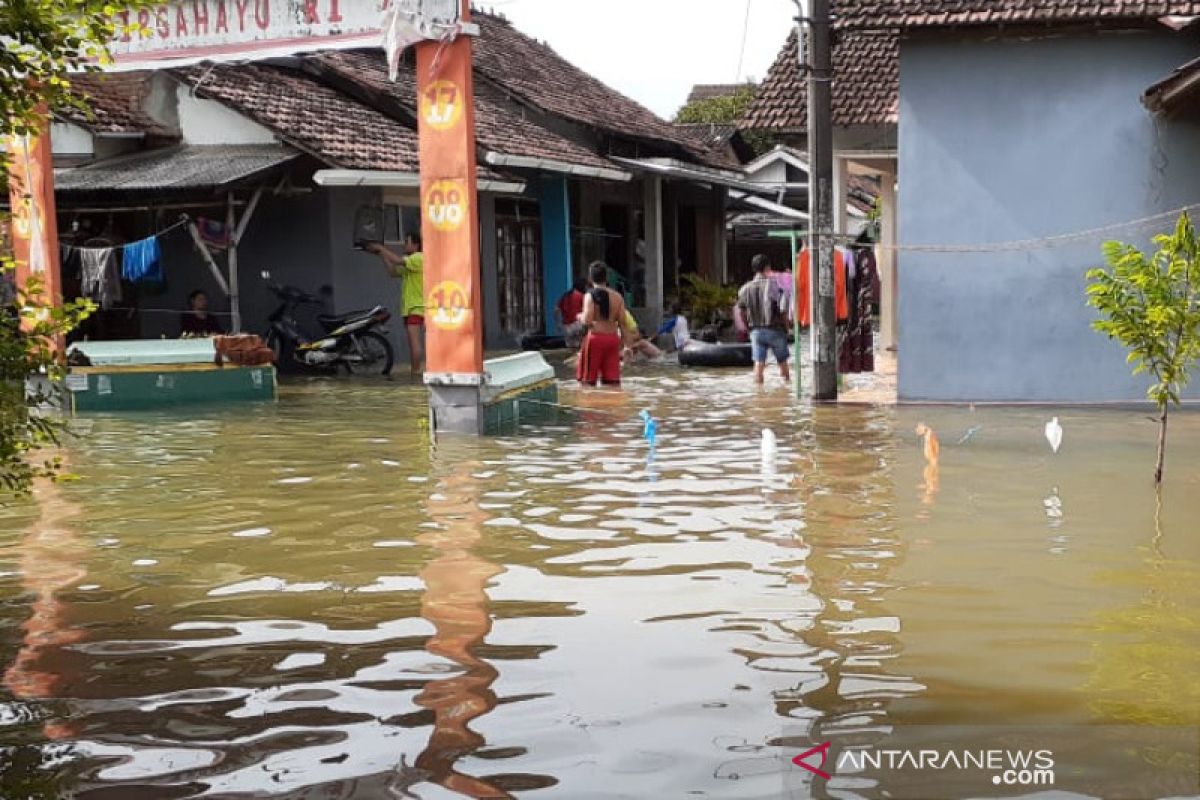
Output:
416,21,484,374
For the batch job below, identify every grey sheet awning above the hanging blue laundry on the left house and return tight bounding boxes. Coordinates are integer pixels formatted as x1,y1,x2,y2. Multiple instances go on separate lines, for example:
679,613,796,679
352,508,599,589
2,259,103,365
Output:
54,144,301,194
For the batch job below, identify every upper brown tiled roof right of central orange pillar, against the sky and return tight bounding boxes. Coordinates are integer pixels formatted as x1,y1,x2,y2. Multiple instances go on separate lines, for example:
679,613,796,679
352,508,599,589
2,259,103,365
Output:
472,12,730,167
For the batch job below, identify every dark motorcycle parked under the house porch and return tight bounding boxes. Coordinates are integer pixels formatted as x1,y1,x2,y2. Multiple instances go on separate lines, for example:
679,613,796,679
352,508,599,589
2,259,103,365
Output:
263,272,395,375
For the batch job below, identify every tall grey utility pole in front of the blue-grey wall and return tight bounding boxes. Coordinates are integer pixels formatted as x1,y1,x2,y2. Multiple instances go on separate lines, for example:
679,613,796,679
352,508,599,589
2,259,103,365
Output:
808,0,838,401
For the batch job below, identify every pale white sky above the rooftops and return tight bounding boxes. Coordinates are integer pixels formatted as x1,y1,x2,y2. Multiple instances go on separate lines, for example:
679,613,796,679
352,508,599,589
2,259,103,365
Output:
475,0,796,119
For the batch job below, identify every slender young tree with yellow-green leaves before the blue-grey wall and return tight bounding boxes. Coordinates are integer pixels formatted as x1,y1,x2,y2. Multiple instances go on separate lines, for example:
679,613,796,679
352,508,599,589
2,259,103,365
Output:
1087,213,1200,486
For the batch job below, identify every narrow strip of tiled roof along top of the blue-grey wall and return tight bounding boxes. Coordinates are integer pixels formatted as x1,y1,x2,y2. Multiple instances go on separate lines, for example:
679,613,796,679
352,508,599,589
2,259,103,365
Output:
834,0,1200,28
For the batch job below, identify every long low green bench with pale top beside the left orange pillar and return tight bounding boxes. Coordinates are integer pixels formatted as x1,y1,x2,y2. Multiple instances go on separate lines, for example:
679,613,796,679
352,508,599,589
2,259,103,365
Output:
66,339,276,413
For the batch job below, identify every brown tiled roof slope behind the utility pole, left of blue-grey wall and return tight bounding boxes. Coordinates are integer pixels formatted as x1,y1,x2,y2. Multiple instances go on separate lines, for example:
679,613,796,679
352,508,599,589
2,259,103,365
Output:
740,31,900,133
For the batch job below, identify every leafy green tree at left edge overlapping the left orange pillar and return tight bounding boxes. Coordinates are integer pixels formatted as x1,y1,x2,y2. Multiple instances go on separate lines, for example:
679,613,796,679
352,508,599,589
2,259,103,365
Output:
0,0,148,499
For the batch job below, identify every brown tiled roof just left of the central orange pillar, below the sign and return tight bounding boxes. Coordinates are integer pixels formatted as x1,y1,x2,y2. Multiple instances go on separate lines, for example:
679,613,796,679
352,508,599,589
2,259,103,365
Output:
173,64,419,173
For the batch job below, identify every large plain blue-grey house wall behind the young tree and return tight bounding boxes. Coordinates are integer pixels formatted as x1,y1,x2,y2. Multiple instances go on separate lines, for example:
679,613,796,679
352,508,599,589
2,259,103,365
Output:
899,31,1200,402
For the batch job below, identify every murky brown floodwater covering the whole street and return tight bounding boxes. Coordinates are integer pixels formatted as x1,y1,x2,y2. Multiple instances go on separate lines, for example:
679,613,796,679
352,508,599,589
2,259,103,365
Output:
0,371,1200,800
